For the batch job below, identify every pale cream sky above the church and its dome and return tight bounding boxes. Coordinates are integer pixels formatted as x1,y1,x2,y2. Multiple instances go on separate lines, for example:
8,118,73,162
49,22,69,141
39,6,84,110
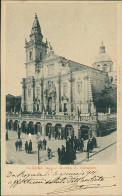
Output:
6,2,117,96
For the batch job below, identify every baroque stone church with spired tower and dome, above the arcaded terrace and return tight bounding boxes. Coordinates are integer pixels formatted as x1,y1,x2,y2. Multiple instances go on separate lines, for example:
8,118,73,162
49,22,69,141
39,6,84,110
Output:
21,14,113,115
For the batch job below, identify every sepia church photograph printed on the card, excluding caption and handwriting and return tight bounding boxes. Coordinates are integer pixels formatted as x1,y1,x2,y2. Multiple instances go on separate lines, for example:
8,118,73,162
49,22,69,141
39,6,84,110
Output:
5,2,117,165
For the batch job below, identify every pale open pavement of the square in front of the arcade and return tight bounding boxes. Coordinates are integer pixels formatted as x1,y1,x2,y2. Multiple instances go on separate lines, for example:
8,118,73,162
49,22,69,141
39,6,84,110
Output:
6,130,117,165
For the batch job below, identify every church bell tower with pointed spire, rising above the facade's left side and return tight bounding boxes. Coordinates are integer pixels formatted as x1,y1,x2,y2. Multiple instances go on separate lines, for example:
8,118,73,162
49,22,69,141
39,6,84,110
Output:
25,14,48,77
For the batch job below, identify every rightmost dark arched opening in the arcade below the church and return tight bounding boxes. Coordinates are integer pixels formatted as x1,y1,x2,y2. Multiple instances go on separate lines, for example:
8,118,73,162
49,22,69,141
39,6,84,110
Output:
79,125,90,140
